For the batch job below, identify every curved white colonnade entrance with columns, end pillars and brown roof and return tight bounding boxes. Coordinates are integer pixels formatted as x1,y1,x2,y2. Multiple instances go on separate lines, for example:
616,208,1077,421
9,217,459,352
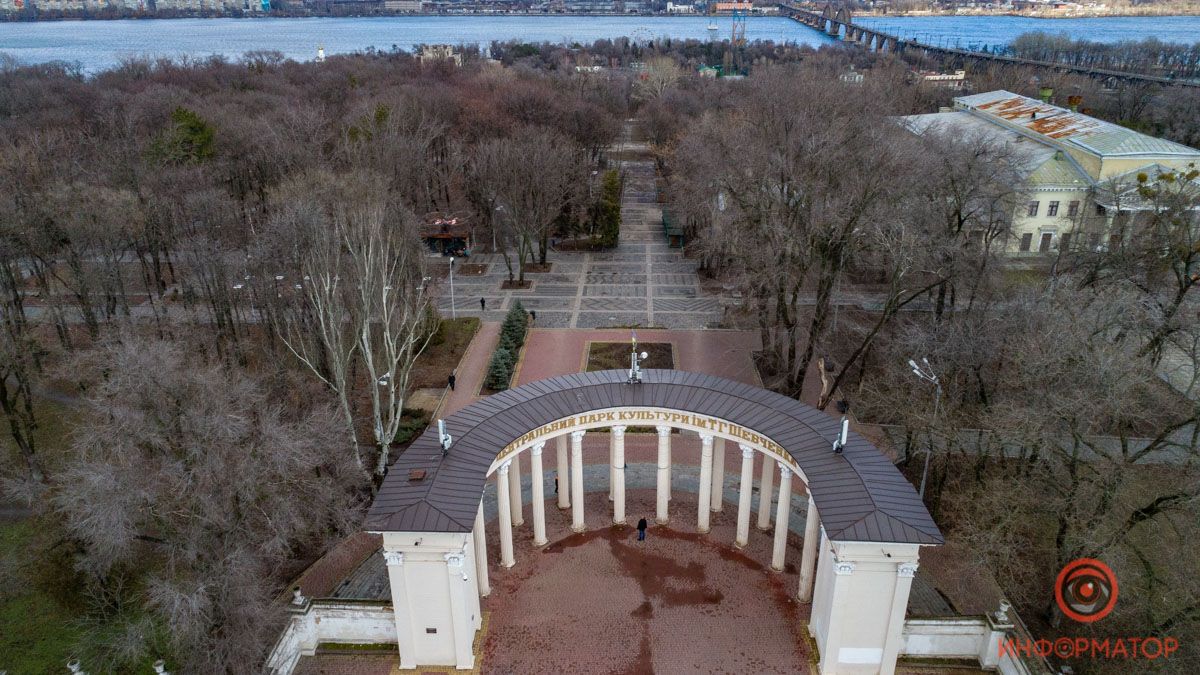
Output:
366,370,942,673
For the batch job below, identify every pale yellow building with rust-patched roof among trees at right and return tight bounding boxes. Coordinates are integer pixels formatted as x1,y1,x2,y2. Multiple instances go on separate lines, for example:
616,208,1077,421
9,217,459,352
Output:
900,90,1200,253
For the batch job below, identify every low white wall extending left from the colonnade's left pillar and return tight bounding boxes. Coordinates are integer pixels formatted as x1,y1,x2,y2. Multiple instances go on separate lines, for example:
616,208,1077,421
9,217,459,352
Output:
266,601,396,675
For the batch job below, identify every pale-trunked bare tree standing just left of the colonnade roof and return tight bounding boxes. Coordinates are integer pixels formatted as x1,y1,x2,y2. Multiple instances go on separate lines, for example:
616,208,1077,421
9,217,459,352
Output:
265,173,437,477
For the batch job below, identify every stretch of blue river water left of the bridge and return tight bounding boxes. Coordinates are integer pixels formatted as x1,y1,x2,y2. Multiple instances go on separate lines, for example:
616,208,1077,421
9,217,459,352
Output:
0,16,834,71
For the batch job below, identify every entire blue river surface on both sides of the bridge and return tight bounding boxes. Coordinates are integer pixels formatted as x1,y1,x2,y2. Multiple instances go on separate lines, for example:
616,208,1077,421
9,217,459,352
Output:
0,16,1200,72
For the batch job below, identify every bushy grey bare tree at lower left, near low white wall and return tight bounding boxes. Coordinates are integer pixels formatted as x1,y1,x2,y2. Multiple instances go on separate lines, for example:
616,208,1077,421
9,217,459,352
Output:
54,340,361,673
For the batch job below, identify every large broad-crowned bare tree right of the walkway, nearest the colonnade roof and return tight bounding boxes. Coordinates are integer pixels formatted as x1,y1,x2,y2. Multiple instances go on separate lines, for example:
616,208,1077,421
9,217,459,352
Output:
673,68,917,394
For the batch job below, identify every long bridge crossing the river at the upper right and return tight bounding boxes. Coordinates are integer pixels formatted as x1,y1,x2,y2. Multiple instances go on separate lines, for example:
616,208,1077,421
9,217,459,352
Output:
779,2,1200,86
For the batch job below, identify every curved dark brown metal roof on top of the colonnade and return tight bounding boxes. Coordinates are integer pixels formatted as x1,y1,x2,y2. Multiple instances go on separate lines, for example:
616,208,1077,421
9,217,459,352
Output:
365,370,943,544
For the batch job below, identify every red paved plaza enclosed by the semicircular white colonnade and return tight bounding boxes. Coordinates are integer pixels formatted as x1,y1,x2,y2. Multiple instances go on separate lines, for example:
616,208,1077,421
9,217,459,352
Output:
482,490,809,674
